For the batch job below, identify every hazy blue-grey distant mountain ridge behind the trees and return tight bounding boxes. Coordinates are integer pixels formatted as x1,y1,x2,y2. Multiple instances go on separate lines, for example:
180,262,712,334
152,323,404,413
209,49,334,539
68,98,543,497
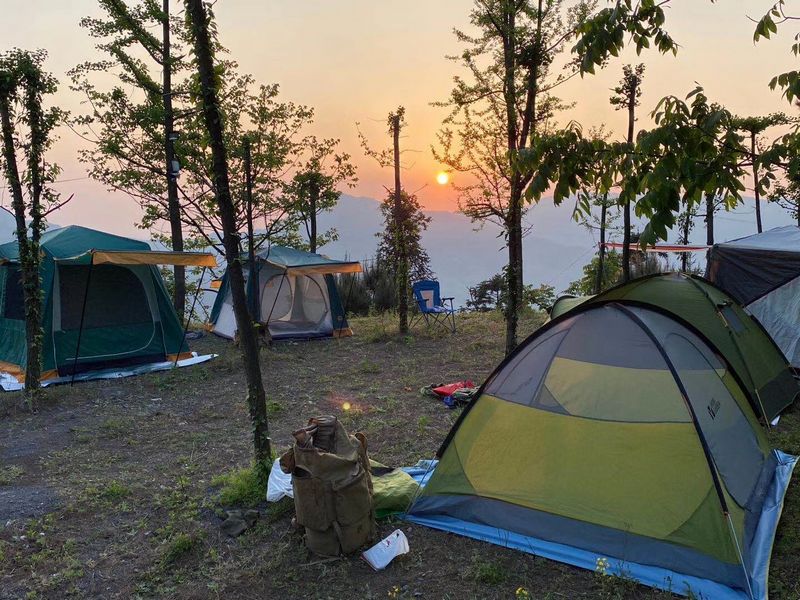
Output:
0,195,795,305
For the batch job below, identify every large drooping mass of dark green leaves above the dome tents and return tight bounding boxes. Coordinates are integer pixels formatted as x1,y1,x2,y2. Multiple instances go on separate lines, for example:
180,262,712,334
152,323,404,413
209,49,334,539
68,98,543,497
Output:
518,87,748,245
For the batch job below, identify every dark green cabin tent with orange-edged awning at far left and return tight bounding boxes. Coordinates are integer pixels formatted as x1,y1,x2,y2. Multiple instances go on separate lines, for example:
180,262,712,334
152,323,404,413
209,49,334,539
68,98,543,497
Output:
0,225,214,382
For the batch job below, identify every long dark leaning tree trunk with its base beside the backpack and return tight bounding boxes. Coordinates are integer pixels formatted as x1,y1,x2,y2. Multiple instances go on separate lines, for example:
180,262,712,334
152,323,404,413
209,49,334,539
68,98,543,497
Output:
185,0,272,467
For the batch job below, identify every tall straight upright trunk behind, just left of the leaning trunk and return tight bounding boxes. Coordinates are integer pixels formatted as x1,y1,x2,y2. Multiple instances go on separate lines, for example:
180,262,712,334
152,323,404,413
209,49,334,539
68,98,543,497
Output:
162,0,186,319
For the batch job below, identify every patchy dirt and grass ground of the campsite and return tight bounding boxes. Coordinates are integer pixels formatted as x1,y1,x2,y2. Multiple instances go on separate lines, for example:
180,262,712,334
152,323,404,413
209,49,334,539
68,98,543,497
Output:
0,315,800,599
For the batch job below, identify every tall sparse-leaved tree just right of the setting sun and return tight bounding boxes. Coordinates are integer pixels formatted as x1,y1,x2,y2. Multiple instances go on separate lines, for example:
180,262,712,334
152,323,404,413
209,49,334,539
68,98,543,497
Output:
434,0,596,353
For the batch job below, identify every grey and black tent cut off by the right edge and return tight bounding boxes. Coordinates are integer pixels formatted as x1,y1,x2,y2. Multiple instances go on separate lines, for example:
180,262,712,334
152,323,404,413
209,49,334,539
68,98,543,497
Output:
706,225,800,369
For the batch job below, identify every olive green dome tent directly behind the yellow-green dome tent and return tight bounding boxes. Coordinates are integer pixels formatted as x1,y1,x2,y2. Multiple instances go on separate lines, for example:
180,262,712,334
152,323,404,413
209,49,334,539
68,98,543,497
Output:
551,273,800,422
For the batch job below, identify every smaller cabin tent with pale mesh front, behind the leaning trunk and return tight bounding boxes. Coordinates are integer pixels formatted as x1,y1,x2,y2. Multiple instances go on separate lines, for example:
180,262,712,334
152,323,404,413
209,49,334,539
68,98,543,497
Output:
209,246,362,339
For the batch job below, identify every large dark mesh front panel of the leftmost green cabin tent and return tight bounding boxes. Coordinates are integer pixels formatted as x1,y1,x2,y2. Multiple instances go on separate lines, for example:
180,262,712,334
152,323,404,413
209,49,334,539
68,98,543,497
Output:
58,265,153,331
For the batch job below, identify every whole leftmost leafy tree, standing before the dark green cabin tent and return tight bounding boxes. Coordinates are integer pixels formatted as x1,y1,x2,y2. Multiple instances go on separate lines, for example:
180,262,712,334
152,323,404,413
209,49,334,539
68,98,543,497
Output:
0,50,64,400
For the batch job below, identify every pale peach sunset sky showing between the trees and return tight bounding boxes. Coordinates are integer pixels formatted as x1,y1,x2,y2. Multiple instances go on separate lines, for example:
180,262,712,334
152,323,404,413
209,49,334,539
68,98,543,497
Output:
0,0,793,235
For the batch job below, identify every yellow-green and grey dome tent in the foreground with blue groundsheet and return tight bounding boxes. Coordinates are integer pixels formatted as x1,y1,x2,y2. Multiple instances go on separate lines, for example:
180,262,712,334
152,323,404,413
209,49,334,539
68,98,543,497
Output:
407,300,797,600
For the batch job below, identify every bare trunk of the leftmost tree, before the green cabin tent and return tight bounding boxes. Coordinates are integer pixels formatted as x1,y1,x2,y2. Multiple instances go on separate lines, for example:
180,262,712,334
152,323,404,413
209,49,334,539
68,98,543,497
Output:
0,90,42,399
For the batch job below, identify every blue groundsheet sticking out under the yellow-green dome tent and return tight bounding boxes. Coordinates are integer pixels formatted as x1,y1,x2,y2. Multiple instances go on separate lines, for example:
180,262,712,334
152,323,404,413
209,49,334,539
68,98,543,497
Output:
402,450,798,600
